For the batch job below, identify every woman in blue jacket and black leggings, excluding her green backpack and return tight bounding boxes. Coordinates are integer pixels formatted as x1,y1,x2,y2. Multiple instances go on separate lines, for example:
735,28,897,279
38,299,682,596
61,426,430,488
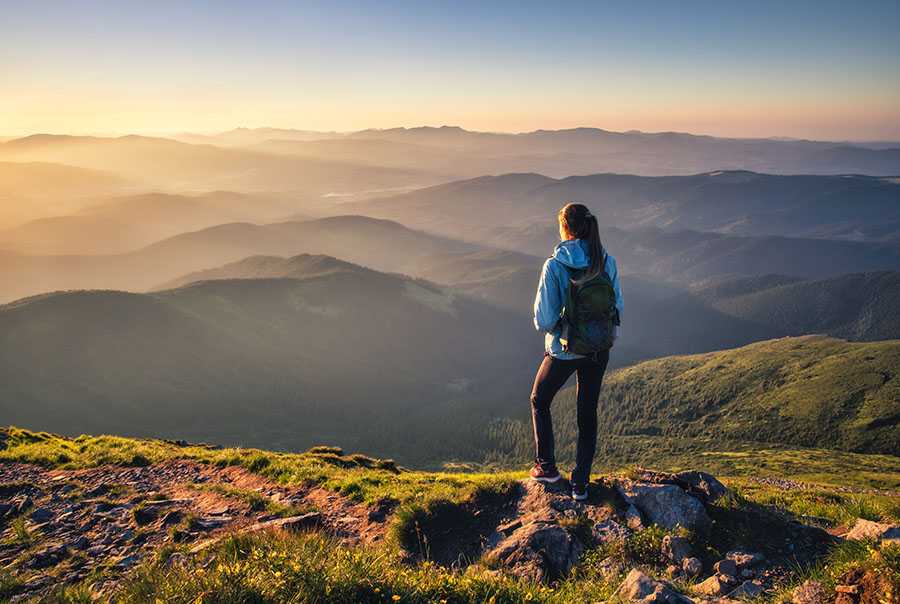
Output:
531,203,622,501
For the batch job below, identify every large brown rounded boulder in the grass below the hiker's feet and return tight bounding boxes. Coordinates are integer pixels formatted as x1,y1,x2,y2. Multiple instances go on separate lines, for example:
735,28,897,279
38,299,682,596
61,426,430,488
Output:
488,522,584,581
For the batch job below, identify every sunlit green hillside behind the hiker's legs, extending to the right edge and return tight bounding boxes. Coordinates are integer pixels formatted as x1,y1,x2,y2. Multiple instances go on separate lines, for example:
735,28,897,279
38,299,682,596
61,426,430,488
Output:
492,336,900,460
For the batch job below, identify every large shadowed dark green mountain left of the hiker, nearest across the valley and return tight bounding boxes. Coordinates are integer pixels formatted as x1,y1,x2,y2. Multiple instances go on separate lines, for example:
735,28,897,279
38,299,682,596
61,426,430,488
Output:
0,267,540,455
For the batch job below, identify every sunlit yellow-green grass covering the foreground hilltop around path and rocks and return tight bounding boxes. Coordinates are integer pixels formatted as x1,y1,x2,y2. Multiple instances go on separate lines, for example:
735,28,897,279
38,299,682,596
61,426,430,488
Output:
0,428,900,602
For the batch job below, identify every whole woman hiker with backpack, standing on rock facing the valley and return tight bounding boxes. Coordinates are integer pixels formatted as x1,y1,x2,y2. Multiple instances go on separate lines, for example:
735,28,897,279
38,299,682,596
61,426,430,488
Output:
531,203,622,501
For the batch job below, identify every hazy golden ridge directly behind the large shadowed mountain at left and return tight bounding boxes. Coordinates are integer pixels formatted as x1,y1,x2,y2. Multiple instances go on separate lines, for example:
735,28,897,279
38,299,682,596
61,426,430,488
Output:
0,216,478,301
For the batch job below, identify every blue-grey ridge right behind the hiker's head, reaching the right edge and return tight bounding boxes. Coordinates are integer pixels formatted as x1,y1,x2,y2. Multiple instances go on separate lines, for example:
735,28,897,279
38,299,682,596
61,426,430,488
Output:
347,171,900,240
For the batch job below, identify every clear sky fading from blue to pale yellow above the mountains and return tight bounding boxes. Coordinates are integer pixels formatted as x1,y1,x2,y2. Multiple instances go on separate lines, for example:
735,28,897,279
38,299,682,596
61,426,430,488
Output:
0,0,900,140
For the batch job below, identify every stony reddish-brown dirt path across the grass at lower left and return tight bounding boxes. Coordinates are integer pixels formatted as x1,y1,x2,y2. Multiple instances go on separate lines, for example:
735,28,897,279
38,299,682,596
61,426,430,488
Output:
0,460,389,595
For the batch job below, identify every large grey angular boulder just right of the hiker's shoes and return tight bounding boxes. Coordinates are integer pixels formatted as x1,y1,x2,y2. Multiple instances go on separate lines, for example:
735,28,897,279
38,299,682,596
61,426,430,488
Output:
616,481,712,533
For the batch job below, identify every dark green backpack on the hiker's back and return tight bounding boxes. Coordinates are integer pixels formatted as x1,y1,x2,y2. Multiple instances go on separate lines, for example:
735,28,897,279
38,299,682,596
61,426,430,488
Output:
560,261,617,355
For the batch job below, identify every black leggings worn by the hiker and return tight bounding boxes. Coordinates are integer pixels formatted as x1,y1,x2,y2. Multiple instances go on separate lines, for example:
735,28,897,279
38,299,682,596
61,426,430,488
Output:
531,351,609,484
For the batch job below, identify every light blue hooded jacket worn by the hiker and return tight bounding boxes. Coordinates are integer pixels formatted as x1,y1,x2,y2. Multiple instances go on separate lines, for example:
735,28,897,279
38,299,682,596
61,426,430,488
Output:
534,239,623,359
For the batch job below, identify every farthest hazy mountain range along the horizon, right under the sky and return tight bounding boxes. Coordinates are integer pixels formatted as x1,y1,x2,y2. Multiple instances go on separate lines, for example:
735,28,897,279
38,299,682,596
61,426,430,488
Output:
174,126,900,177
